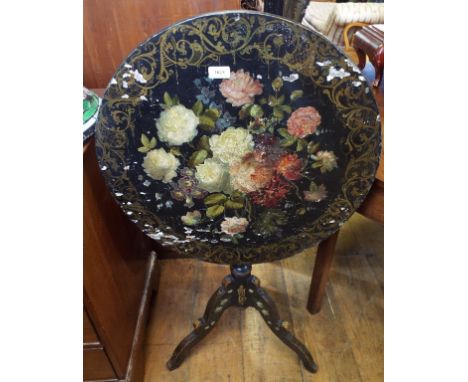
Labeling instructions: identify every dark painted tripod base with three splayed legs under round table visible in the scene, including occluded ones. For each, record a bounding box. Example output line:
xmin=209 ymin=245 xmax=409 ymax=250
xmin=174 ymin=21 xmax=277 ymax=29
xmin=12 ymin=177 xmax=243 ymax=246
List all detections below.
xmin=166 ymin=264 xmax=317 ymax=373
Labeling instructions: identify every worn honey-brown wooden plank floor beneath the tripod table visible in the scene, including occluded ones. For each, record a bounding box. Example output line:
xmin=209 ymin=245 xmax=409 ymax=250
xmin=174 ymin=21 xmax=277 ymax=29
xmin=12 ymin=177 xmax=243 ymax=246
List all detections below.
xmin=145 ymin=214 xmax=384 ymax=382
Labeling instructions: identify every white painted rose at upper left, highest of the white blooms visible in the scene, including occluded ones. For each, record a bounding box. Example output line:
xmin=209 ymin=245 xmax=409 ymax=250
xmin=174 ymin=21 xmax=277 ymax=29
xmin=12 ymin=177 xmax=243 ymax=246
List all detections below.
xmin=156 ymin=105 xmax=200 ymax=146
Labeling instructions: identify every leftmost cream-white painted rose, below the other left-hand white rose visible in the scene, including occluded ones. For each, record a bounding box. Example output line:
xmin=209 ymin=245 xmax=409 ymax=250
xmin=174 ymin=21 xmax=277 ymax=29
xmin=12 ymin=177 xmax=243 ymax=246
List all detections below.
xmin=143 ymin=149 xmax=180 ymax=183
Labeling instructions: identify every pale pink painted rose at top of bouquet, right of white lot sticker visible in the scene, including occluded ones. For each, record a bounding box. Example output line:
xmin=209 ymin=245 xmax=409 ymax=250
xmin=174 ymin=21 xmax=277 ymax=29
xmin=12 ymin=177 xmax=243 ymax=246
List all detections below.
xmin=219 ymin=69 xmax=263 ymax=106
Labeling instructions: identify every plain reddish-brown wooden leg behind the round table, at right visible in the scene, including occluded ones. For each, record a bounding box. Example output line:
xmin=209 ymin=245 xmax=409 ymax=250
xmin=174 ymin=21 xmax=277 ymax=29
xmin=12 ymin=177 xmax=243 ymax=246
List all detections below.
xmin=307 ymin=231 xmax=339 ymax=314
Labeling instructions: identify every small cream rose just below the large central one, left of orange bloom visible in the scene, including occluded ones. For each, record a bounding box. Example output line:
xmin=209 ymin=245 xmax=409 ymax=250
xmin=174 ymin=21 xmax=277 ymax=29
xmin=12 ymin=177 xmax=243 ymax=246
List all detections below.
xmin=195 ymin=158 xmax=229 ymax=192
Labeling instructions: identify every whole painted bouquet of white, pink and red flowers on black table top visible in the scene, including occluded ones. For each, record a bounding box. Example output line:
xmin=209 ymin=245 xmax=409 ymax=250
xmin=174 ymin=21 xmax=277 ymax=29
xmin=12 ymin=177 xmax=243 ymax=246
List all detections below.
xmin=138 ymin=69 xmax=339 ymax=244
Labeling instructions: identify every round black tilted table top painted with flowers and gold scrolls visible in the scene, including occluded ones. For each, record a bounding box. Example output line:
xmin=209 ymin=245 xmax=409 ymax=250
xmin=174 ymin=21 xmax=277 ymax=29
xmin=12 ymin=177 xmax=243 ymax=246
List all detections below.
xmin=96 ymin=11 xmax=380 ymax=264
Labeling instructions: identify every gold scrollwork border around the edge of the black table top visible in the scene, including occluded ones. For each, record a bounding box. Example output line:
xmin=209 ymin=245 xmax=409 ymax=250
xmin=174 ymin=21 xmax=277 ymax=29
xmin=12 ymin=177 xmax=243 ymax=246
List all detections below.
xmin=96 ymin=11 xmax=380 ymax=264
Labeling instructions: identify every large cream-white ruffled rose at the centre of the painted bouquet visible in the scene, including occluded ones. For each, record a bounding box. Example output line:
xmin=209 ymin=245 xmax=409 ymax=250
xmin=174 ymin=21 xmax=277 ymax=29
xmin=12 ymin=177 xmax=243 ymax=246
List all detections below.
xmin=209 ymin=127 xmax=254 ymax=165
